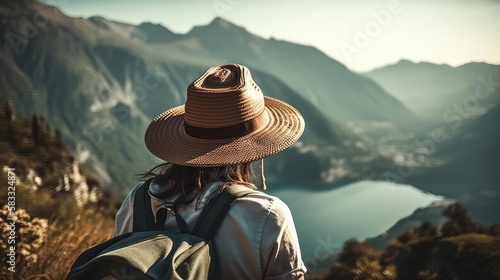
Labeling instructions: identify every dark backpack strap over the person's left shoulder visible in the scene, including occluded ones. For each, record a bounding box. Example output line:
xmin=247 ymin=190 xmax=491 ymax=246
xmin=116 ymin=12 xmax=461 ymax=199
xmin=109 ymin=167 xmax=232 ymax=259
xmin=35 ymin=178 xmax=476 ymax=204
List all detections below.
xmin=133 ymin=179 xmax=156 ymax=231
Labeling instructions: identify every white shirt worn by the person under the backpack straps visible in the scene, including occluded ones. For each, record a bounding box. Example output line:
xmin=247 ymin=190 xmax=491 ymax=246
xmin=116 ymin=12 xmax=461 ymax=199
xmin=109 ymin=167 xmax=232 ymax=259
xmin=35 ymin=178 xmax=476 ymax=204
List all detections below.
xmin=114 ymin=181 xmax=306 ymax=280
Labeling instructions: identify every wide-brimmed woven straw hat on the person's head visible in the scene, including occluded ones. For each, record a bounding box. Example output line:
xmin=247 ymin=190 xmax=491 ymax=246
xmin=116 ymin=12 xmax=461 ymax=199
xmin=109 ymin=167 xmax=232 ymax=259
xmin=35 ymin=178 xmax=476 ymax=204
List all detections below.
xmin=145 ymin=64 xmax=305 ymax=167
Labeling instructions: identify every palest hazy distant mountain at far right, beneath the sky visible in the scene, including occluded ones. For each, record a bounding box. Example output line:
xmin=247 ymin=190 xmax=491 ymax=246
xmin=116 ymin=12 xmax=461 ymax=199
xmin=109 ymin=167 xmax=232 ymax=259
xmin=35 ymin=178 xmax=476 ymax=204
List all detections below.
xmin=364 ymin=60 xmax=500 ymax=123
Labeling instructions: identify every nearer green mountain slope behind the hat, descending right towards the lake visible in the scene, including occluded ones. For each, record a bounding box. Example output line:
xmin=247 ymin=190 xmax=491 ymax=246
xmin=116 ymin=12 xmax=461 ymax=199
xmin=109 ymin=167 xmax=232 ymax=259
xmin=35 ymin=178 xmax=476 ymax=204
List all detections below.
xmin=0 ymin=0 xmax=391 ymax=194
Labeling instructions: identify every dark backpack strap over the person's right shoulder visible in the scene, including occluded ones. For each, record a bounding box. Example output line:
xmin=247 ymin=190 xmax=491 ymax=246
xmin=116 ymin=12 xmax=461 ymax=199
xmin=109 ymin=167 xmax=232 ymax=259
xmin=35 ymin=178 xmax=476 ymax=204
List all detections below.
xmin=192 ymin=184 xmax=255 ymax=240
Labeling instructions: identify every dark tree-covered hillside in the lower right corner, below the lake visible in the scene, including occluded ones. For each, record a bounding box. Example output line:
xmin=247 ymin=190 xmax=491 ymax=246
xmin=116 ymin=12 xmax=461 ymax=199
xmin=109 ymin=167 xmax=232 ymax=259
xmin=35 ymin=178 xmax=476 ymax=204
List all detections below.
xmin=308 ymin=203 xmax=500 ymax=280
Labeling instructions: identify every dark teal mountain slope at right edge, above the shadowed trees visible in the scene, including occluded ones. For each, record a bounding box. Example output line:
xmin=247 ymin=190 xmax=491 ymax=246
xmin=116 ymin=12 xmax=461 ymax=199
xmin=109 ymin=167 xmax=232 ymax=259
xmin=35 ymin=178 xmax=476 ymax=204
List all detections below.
xmin=408 ymin=99 xmax=500 ymax=225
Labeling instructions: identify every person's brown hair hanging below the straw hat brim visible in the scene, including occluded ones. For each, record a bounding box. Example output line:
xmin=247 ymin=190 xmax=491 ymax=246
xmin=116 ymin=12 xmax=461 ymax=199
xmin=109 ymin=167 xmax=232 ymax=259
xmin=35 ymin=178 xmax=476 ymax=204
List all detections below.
xmin=139 ymin=162 xmax=255 ymax=202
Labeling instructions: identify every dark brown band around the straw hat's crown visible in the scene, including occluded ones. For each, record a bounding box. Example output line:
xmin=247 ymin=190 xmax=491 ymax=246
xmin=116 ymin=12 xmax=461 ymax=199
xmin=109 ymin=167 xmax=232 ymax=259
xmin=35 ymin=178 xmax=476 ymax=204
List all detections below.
xmin=184 ymin=111 xmax=268 ymax=140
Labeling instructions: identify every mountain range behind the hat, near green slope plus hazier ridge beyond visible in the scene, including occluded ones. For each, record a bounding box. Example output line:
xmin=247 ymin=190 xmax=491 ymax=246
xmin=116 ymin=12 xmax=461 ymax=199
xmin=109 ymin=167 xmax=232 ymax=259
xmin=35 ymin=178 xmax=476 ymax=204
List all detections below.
xmin=0 ymin=0 xmax=402 ymax=193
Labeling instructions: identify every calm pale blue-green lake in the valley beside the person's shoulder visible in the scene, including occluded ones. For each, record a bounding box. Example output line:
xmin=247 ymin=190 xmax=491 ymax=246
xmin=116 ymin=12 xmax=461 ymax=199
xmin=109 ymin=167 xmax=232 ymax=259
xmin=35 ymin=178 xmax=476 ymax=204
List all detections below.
xmin=266 ymin=181 xmax=443 ymax=258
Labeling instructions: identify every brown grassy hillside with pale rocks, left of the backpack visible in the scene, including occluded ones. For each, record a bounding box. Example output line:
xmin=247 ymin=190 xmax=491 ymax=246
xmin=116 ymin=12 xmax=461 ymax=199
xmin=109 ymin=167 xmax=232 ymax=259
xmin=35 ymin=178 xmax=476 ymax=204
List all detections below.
xmin=0 ymin=102 xmax=119 ymax=280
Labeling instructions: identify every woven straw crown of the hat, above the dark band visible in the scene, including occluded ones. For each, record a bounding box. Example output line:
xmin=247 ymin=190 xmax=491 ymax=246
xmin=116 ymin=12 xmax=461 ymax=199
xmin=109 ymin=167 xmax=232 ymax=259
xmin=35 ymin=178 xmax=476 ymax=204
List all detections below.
xmin=184 ymin=64 xmax=265 ymax=128
